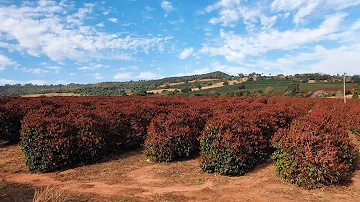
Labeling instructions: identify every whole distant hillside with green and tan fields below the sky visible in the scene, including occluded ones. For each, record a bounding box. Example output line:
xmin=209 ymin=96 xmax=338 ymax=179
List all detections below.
xmin=0 ymin=71 xmax=360 ymax=96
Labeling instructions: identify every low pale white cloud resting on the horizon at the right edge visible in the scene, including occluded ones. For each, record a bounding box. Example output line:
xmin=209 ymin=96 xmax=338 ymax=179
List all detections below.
xmin=247 ymin=44 xmax=360 ymax=75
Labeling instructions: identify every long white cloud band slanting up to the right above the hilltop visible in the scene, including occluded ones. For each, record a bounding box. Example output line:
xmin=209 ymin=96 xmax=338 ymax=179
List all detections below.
xmin=200 ymin=14 xmax=346 ymax=63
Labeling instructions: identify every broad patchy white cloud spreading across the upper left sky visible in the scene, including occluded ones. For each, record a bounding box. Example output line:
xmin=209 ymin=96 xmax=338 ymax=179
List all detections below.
xmin=0 ymin=2 xmax=172 ymax=63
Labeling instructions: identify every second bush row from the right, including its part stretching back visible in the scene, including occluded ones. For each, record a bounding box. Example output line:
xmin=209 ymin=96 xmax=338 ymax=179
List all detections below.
xmin=200 ymin=99 xmax=304 ymax=175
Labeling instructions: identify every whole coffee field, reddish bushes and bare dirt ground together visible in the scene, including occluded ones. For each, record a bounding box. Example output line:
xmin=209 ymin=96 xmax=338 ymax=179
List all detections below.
xmin=0 ymin=96 xmax=360 ymax=201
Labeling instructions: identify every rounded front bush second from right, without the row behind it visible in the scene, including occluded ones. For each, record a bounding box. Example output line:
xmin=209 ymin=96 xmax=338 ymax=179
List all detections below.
xmin=200 ymin=111 xmax=273 ymax=175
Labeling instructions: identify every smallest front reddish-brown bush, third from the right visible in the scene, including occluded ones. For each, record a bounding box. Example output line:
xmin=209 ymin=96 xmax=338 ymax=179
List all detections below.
xmin=145 ymin=109 xmax=204 ymax=162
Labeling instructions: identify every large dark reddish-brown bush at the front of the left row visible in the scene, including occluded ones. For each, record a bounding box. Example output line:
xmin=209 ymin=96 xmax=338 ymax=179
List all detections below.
xmin=21 ymin=106 xmax=106 ymax=172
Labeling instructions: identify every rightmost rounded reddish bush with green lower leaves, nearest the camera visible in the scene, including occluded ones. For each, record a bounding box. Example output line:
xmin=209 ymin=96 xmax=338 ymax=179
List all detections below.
xmin=272 ymin=110 xmax=355 ymax=188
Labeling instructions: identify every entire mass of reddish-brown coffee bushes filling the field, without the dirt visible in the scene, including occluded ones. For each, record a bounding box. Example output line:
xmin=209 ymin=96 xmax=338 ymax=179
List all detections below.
xmin=0 ymin=97 xmax=360 ymax=188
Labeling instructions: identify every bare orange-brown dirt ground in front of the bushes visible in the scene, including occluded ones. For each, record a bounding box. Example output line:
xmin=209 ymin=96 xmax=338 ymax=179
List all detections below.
xmin=0 ymin=143 xmax=360 ymax=202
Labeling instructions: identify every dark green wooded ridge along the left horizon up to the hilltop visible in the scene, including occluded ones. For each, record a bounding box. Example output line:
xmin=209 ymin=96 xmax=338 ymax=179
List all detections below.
xmin=0 ymin=71 xmax=231 ymax=96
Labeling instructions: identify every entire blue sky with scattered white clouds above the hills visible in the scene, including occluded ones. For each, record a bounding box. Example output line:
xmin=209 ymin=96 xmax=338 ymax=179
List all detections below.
xmin=0 ymin=0 xmax=360 ymax=85
